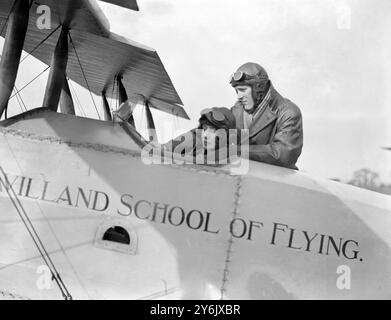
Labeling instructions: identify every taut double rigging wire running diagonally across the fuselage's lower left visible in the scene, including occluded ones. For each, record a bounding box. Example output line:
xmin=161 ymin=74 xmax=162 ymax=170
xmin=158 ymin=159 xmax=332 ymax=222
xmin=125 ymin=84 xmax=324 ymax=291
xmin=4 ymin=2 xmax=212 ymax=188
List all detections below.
xmin=0 ymin=167 xmax=72 ymax=300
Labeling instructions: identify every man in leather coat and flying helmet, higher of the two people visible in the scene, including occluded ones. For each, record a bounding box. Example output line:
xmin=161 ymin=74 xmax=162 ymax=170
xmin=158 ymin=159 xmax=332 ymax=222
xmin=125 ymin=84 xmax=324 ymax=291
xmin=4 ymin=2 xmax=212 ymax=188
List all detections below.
xmin=230 ymin=62 xmax=303 ymax=169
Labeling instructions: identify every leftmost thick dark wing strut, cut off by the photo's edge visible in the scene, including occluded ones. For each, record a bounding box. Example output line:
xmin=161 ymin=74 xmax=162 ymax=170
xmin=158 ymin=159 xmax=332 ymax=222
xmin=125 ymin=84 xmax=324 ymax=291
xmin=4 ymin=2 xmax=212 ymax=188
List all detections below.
xmin=0 ymin=0 xmax=30 ymax=117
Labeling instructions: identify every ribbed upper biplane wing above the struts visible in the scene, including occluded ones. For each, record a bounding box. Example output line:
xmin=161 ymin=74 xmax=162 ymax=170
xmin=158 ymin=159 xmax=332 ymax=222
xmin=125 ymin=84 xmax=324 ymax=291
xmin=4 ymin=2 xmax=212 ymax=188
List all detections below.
xmin=0 ymin=0 xmax=188 ymax=119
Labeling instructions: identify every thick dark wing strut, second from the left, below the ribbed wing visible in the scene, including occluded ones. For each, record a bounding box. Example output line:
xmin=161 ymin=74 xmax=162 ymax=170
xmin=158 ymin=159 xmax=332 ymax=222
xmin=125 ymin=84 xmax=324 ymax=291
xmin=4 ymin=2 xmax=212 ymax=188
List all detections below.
xmin=42 ymin=26 xmax=69 ymax=111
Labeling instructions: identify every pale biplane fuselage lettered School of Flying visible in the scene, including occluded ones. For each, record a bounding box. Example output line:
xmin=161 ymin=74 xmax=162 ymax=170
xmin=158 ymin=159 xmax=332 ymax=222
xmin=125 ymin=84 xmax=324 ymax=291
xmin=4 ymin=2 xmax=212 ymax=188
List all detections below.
xmin=0 ymin=0 xmax=391 ymax=299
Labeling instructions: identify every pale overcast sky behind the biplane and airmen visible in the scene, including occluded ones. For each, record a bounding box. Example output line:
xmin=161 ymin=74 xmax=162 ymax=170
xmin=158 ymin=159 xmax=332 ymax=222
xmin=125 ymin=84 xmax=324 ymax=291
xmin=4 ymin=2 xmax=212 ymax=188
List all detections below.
xmin=3 ymin=0 xmax=391 ymax=182
